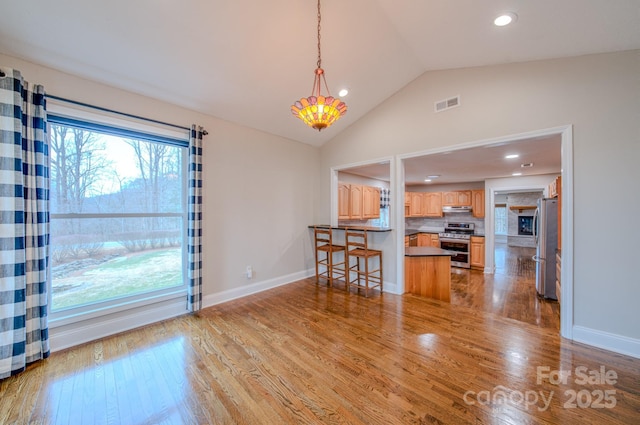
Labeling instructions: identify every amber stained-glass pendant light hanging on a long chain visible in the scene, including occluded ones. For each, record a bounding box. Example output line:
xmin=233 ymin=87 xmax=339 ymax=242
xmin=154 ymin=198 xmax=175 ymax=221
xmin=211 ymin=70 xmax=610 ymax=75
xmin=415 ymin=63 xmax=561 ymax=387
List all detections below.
xmin=291 ymin=0 xmax=347 ymax=131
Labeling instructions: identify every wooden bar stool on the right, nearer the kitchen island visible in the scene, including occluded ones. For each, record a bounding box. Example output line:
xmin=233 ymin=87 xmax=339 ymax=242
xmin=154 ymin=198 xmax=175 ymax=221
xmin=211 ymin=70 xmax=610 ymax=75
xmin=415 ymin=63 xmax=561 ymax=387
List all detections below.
xmin=345 ymin=229 xmax=382 ymax=297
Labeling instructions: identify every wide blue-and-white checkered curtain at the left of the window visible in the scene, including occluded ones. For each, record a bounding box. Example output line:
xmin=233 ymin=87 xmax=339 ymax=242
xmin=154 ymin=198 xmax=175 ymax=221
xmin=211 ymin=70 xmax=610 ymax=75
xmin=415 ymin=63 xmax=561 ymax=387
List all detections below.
xmin=0 ymin=68 xmax=49 ymax=379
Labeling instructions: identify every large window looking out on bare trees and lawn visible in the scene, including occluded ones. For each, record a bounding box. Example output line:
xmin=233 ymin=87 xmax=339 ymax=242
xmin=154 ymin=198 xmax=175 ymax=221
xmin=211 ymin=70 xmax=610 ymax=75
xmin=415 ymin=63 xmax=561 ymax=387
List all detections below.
xmin=49 ymin=114 xmax=187 ymax=313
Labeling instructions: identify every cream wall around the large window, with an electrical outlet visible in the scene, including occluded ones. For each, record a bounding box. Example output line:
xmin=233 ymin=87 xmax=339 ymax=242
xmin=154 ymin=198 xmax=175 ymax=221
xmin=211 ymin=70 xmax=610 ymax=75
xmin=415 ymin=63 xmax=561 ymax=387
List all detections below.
xmin=0 ymin=55 xmax=320 ymax=344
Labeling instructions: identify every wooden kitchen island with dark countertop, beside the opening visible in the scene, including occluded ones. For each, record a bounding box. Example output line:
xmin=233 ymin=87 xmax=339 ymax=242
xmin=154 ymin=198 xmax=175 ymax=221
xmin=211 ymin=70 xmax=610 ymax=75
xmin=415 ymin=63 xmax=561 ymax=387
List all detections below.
xmin=404 ymin=246 xmax=454 ymax=302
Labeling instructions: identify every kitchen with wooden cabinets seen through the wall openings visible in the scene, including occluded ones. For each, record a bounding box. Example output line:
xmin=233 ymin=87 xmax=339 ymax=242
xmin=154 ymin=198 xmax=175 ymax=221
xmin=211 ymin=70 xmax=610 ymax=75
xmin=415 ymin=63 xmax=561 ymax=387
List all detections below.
xmin=336 ymin=137 xmax=561 ymax=323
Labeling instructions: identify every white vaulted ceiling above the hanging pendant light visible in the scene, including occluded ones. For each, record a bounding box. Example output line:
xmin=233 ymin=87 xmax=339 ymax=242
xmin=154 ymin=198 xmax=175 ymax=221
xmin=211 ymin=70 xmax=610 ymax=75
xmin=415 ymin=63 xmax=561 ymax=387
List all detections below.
xmin=0 ymin=0 xmax=640 ymax=146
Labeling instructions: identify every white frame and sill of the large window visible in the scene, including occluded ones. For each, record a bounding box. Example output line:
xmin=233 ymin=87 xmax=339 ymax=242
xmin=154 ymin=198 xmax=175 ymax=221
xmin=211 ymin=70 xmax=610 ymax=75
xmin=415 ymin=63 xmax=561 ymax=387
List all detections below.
xmin=47 ymin=99 xmax=189 ymax=330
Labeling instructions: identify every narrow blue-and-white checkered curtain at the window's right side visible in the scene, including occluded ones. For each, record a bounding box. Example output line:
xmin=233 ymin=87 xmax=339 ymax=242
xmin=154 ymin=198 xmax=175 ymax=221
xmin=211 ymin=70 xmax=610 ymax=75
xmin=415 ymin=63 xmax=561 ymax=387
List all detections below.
xmin=187 ymin=125 xmax=206 ymax=311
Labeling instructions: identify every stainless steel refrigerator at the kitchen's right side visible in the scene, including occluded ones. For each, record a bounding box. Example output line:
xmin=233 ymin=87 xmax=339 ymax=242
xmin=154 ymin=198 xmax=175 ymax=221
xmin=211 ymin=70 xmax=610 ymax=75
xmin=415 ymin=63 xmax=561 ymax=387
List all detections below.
xmin=533 ymin=198 xmax=558 ymax=300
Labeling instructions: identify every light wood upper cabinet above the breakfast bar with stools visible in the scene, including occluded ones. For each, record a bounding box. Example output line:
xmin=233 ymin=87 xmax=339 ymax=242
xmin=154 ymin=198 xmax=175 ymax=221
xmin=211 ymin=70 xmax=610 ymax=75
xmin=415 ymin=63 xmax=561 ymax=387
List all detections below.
xmin=338 ymin=182 xmax=380 ymax=220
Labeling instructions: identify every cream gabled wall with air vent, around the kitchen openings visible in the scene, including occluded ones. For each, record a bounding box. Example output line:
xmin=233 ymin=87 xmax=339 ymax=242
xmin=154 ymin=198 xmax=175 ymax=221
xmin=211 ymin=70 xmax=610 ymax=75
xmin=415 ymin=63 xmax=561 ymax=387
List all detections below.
xmin=321 ymin=51 xmax=640 ymax=356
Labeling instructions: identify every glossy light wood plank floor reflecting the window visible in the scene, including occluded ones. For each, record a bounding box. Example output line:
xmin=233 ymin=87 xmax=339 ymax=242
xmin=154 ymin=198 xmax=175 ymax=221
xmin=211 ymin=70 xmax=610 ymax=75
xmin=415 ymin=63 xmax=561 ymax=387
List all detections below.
xmin=0 ymin=258 xmax=640 ymax=425
